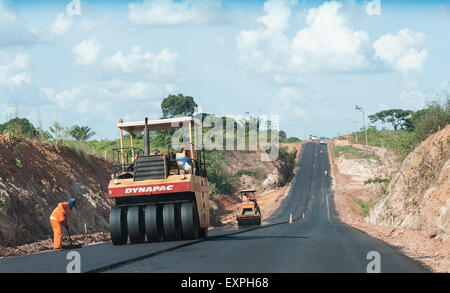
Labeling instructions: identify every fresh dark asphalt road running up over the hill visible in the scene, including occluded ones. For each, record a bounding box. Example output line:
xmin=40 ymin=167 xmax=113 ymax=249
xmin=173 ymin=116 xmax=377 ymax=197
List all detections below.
xmin=0 ymin=143 xmax=427 ymax=273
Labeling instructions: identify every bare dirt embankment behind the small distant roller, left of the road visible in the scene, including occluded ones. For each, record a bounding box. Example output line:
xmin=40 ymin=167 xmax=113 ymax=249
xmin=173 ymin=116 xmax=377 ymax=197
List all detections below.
xmin=211 ymin=142 xmax=304 ymax=226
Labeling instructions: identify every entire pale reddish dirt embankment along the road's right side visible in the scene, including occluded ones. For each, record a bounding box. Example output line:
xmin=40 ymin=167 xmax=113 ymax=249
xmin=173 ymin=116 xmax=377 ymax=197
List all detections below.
xmin=329 ymin=126 xmax=450 ymax=272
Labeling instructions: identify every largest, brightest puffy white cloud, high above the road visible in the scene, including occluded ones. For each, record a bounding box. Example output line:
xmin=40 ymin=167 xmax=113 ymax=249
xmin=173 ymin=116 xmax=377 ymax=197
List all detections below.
xmin=236 ymin=0 xmax=372 ymax=74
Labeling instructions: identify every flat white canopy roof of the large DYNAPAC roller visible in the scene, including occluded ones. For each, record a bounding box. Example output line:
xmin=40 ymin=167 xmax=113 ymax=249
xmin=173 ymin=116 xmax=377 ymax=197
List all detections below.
xmin=117 ymin=116 xmax=201 ymax=133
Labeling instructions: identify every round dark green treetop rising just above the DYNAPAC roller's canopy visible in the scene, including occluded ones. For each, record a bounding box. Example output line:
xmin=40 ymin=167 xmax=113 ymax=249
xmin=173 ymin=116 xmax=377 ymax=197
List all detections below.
xmin=161 ymin=94 xmax=197 ymax=118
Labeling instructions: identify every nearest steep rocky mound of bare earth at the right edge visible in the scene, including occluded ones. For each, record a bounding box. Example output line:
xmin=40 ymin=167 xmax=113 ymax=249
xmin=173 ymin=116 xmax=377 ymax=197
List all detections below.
xmin=369 ymin=125 xmax=450 ymax=239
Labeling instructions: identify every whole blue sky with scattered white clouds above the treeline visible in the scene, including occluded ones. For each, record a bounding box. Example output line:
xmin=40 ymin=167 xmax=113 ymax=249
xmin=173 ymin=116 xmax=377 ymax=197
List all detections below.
xmin=0 ymin=0 xmax=450 ymax=139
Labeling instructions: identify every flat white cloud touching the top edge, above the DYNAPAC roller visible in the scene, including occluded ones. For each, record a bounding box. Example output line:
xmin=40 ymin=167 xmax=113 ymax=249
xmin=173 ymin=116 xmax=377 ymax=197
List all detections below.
xmin=128 ymin=0 xmax=224 ymax=26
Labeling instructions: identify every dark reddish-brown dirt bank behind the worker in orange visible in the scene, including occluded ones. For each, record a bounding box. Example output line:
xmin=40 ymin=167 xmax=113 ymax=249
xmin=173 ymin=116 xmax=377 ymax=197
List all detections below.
xmin=0 ymin=135 xmax=112 ymax=247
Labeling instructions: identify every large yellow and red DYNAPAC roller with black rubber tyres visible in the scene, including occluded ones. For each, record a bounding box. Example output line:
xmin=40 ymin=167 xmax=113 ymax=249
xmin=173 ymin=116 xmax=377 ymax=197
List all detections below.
xmin=108 ymin=117 xmax=209 ymax=245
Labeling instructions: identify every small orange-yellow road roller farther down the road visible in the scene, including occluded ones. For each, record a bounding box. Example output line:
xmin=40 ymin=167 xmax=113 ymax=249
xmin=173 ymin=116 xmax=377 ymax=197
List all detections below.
xmin=236 ymin=189 xmax=261 ymax=227
